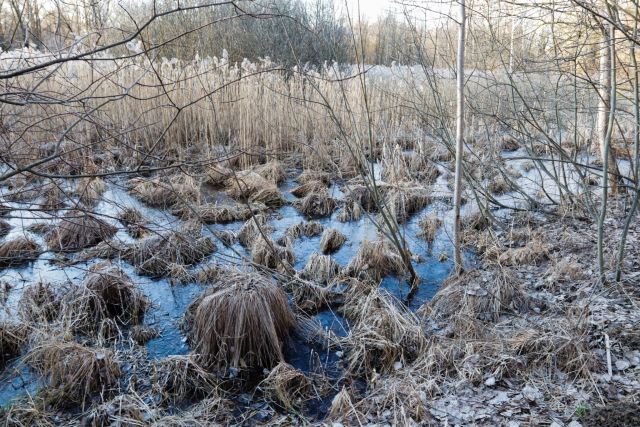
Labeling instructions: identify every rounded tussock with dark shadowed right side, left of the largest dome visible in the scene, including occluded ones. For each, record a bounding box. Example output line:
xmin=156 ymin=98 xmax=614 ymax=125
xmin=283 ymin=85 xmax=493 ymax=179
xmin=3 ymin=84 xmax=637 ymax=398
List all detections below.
xmin=63 ymin=263 xmax=150 ymax=333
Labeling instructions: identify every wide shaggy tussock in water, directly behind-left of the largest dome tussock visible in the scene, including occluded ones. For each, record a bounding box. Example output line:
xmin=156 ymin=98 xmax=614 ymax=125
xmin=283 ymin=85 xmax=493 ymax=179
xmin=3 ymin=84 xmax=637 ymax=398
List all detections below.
xmin=124 ymin=223 xmax=217 ymax=277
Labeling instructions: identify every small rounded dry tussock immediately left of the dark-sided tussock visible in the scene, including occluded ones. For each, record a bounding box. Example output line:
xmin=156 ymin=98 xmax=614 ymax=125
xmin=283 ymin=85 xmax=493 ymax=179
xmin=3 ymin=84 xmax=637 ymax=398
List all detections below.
xmin=18 ymin=281 xmax=60 ymax=323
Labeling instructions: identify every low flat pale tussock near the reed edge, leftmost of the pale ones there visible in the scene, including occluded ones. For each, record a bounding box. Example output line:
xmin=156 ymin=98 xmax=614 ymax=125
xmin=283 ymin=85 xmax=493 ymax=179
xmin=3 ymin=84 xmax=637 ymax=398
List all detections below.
xmin=129 ymin=174 xmax=200 ymax=209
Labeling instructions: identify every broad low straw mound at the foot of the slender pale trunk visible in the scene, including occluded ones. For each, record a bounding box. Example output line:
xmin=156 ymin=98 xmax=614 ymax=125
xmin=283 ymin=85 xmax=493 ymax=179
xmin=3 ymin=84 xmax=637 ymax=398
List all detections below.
xmin=421 ymin=270 xmax=528 ymax=322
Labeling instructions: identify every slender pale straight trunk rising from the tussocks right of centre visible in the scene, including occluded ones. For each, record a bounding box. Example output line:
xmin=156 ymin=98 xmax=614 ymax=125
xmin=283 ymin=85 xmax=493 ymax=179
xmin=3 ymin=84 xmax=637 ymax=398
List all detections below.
xmin=453 ymin=0 xmax=466 ymax=273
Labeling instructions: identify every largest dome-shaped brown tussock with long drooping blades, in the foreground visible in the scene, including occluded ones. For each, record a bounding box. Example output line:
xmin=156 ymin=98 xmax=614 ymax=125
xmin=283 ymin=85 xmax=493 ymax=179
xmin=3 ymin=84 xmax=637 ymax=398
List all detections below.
xmin=188 ymin=271 xmax=295 ymax=368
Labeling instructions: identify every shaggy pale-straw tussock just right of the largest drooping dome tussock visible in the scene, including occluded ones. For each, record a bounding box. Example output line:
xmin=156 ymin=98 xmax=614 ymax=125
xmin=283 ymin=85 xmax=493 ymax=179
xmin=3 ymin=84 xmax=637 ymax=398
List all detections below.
xmin=345 ymin=289 xmax=426 ymax=376
